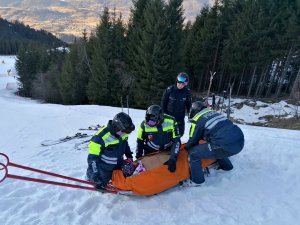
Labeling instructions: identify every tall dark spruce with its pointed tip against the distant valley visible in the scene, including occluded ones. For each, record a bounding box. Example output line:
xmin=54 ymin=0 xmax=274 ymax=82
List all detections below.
xmin=88 ymin=8 xmax=130 ymax=106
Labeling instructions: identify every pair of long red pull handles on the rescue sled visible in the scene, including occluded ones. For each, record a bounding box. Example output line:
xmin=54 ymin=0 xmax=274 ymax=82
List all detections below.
xmin=0 ymin=153 xmax=97 ymax=191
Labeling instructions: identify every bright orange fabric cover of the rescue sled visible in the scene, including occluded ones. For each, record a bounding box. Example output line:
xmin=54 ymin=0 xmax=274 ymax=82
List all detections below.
xmin=112 ymin=145 xmax=215 ymax=196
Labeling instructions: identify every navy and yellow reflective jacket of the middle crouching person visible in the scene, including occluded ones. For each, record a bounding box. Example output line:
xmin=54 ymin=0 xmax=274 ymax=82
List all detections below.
xmin=136 ymin=114 xmax=180 ymax=160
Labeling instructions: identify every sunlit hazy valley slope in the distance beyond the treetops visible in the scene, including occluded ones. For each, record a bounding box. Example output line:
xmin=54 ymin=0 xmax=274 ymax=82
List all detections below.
xmin=0 ymin=0 xmax=213 ymax=41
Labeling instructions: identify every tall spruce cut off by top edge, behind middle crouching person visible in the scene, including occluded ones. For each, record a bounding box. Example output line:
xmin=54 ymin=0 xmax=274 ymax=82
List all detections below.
xmin=134 ymin=0 xmax=171 ymax=107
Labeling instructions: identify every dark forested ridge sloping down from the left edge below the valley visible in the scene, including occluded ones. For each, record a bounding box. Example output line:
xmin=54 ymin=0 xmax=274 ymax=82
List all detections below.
xmin=0 ymin=17 xmax=65 ymax=55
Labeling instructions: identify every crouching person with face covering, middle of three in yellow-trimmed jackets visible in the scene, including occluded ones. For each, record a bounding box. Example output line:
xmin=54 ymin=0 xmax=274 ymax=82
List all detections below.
xmin=136 ymin=105 xmax=180 ymax=172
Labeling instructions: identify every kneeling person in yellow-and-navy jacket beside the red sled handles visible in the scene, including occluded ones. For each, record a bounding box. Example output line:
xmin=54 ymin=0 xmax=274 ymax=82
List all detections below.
xmin=87 ymin=112 xmax=135 ymax=189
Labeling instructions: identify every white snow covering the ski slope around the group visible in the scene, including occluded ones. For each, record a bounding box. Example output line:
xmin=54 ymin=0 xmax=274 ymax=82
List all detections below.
xmin=0 ymin=56 xmax=300 ymax=225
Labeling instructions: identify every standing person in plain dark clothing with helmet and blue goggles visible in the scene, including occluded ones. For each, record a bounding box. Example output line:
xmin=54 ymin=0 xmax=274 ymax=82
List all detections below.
xmin=161 ymin=72 xmax=192 ymax=136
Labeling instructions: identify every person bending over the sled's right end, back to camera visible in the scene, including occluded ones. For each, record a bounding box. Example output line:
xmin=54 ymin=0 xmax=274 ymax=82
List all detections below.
xmin=185 ymin=101 xmax=244 ymax=186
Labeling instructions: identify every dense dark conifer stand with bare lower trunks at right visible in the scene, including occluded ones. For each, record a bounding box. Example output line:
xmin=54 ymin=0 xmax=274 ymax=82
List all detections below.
xmin=184 ymin=0 xmax=300 ymax=97
